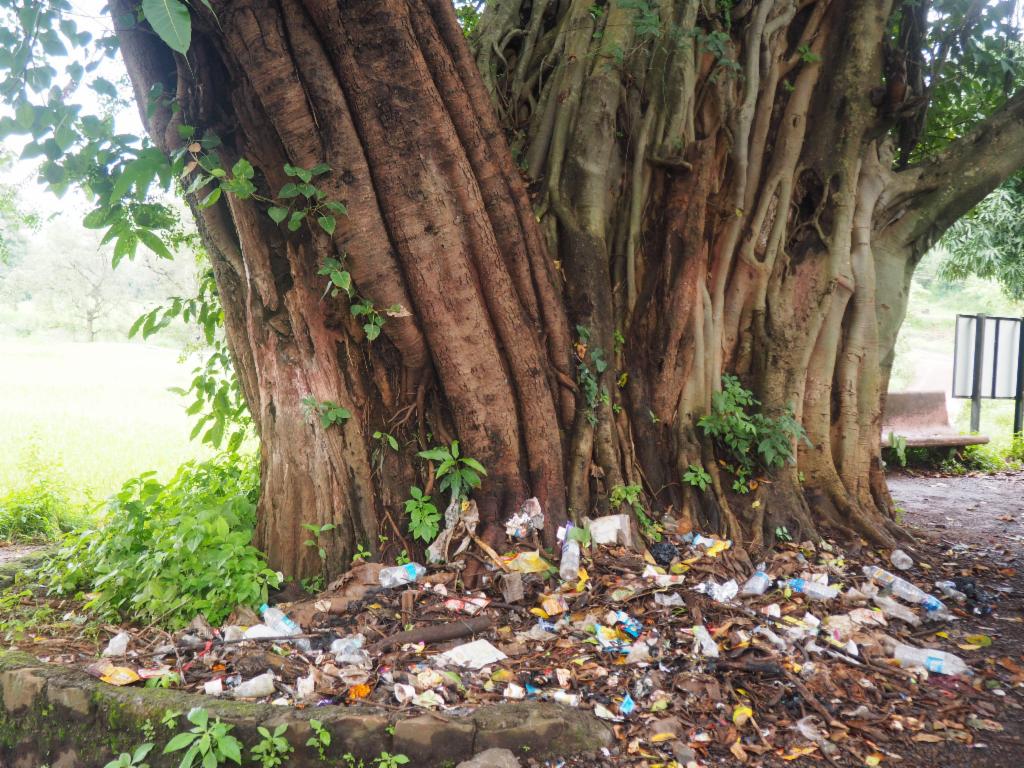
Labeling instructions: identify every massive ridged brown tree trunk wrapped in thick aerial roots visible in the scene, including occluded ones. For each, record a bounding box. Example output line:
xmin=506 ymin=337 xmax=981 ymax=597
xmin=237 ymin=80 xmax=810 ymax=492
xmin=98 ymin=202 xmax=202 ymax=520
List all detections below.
xmin=114 ymin=0 xmax=1020 ymax=575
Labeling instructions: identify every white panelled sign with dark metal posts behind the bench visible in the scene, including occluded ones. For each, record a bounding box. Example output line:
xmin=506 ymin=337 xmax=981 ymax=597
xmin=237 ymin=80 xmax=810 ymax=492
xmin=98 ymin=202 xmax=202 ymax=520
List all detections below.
xmin=952 ymin=314 xmax=1024 ymax=432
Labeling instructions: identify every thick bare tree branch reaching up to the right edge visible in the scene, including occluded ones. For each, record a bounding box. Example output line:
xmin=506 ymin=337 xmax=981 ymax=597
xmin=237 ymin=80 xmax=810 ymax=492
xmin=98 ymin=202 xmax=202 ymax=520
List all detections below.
xmin=874 ymin=90 xmax=1024 ymax=258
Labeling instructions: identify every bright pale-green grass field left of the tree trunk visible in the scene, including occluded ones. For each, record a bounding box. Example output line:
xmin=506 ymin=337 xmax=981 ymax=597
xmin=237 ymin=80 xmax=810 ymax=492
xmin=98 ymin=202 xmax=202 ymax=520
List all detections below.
xmin=0 ymin=340 xmax=211 ymax=502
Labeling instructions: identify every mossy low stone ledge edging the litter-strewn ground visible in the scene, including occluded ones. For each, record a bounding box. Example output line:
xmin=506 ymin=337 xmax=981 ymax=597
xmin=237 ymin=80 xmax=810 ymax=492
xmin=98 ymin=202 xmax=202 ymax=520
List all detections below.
xmin=0 ymin=651 xmax=612 ymax=768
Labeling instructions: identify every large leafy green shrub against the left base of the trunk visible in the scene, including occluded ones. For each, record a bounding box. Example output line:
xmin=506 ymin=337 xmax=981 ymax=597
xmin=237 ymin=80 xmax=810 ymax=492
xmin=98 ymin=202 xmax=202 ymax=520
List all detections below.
xmin=40 ymin=454 xmax=280 ymax=628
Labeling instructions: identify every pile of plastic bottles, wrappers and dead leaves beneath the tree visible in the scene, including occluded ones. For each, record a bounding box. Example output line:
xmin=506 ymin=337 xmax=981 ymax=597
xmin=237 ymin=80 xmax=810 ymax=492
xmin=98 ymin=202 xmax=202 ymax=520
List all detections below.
xmin=32 ymin=500 xmax=1024 ymax=766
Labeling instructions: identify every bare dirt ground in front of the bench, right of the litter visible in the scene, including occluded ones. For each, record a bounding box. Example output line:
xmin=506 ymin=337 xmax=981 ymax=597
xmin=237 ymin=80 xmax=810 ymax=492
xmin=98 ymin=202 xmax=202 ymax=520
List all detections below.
xmin=889 ymin=472 xmax=1024 ymax=768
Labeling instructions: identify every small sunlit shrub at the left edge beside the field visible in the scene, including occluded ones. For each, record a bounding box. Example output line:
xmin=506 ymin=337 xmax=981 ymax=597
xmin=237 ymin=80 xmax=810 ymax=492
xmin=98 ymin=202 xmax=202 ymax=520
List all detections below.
xmin=0 ymin=447 xmax=87 ymax=542
